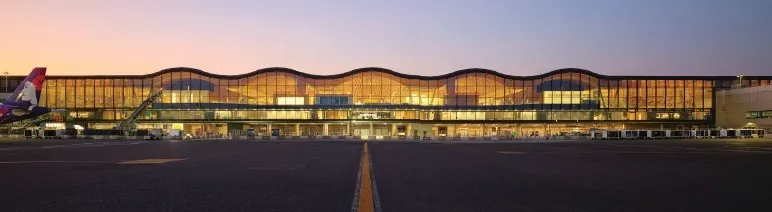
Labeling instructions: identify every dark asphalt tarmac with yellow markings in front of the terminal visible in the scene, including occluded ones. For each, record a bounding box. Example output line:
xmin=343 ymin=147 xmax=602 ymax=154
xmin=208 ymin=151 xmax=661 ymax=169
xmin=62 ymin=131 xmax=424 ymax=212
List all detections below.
xmin=0 ymin=139 xmax=772 ymax=211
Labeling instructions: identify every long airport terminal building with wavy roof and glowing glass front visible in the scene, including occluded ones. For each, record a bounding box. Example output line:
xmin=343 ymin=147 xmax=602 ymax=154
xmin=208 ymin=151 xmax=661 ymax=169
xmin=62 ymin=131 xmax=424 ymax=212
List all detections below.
xmin=0 ymin=68 xmax=772 ymax=136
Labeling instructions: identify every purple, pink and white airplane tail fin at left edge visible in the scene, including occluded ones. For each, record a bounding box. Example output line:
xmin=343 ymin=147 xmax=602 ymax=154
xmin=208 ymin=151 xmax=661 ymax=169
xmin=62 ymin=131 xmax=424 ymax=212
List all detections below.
xmin=3 ymin=67 xmax=46 ymax=105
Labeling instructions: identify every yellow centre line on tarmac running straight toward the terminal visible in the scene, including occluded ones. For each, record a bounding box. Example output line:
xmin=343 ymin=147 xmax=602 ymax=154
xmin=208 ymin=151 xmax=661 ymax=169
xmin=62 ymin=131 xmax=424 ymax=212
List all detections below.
xmin=351 ymin=142 xmax=381 ymax=212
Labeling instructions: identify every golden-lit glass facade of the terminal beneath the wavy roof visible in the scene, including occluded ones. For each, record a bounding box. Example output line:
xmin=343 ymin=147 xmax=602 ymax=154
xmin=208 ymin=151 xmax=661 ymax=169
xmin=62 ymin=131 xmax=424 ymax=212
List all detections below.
xmin=28 ymin=68 xmax=770 ymax=123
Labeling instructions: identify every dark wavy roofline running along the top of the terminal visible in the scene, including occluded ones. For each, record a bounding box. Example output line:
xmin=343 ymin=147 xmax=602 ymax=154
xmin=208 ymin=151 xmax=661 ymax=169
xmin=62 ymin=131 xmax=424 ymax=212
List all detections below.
xmin=50 ymin=67 xmax=772 ymax=80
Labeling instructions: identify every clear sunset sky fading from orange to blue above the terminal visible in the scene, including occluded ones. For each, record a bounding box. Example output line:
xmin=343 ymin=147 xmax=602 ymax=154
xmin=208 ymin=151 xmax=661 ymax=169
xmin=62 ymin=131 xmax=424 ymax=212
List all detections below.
xmin=0 ymin=0 xmax=772 ymax=76
